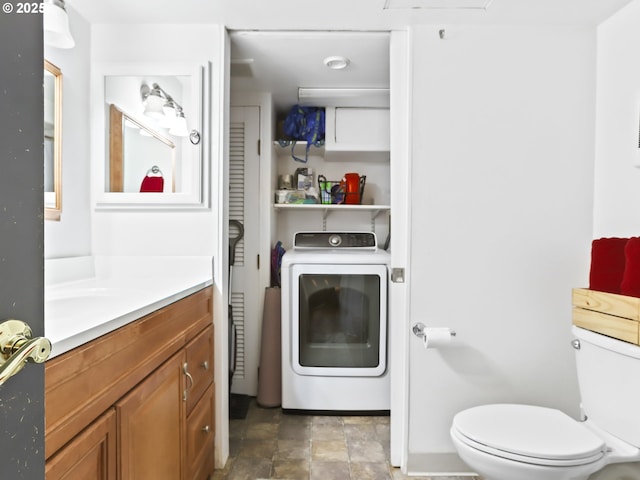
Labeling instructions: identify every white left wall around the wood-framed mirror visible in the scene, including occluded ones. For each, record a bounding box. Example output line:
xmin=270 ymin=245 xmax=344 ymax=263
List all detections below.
xmin=44 ymin=5 xmax=91 ymax=258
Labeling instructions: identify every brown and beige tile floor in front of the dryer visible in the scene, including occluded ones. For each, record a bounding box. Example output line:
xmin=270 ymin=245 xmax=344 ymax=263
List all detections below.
xmin=213 ymin=399 xmax=472 ymax=480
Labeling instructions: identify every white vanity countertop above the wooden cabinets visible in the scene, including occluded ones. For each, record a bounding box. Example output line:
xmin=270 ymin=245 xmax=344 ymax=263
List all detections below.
xmin=44 ymin=257 xmax=213 ymax=358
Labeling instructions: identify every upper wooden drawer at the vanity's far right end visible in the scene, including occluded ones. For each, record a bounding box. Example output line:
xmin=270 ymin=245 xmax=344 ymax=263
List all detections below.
xmin=186 ymin=325 xmax=213 ymax=414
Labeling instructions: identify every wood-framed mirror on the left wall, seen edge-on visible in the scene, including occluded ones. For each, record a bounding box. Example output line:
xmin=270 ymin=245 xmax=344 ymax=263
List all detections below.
xmin=44 ymin=60 xmax=62 ymax=221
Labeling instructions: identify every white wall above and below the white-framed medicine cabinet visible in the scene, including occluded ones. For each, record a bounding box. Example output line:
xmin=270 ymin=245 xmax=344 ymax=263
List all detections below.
xmin=91 ymin=25 xmax=222 ymax=255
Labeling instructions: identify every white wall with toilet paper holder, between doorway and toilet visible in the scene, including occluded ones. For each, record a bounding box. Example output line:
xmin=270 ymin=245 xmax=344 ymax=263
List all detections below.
xmin=405 ymin=26 xmax=596 ymax=472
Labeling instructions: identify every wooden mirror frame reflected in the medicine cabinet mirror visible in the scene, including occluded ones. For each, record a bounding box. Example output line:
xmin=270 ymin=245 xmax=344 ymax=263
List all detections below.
xmin=109 ymin=103 xmax=176 ymax=192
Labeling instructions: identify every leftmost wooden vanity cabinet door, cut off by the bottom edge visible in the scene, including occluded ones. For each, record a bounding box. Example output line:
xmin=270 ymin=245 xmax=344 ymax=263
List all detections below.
xmin=45 ymin=409 xmax=117 ymax=480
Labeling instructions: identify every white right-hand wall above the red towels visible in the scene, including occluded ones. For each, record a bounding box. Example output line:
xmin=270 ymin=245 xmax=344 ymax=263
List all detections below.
xmin=593 ymin=0 xmax=640 ymax=238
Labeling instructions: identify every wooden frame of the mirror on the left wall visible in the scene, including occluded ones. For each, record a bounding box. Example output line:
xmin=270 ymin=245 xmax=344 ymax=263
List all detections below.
xmin=43 ymin=60 xmax=62 ymax=221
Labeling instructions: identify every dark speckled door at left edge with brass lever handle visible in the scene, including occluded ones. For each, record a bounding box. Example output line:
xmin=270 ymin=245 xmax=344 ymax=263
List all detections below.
xmin=0 ymin=7 xmax=44 ymax=480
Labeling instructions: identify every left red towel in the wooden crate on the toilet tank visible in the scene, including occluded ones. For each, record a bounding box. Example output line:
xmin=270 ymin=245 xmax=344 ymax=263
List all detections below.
xmin=589 ymin=237 xmax=640 ymax=293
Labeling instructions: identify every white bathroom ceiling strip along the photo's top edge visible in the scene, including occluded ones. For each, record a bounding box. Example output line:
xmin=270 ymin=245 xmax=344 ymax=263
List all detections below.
xmin=67 ymin=0 xmax=638 ymax=30
